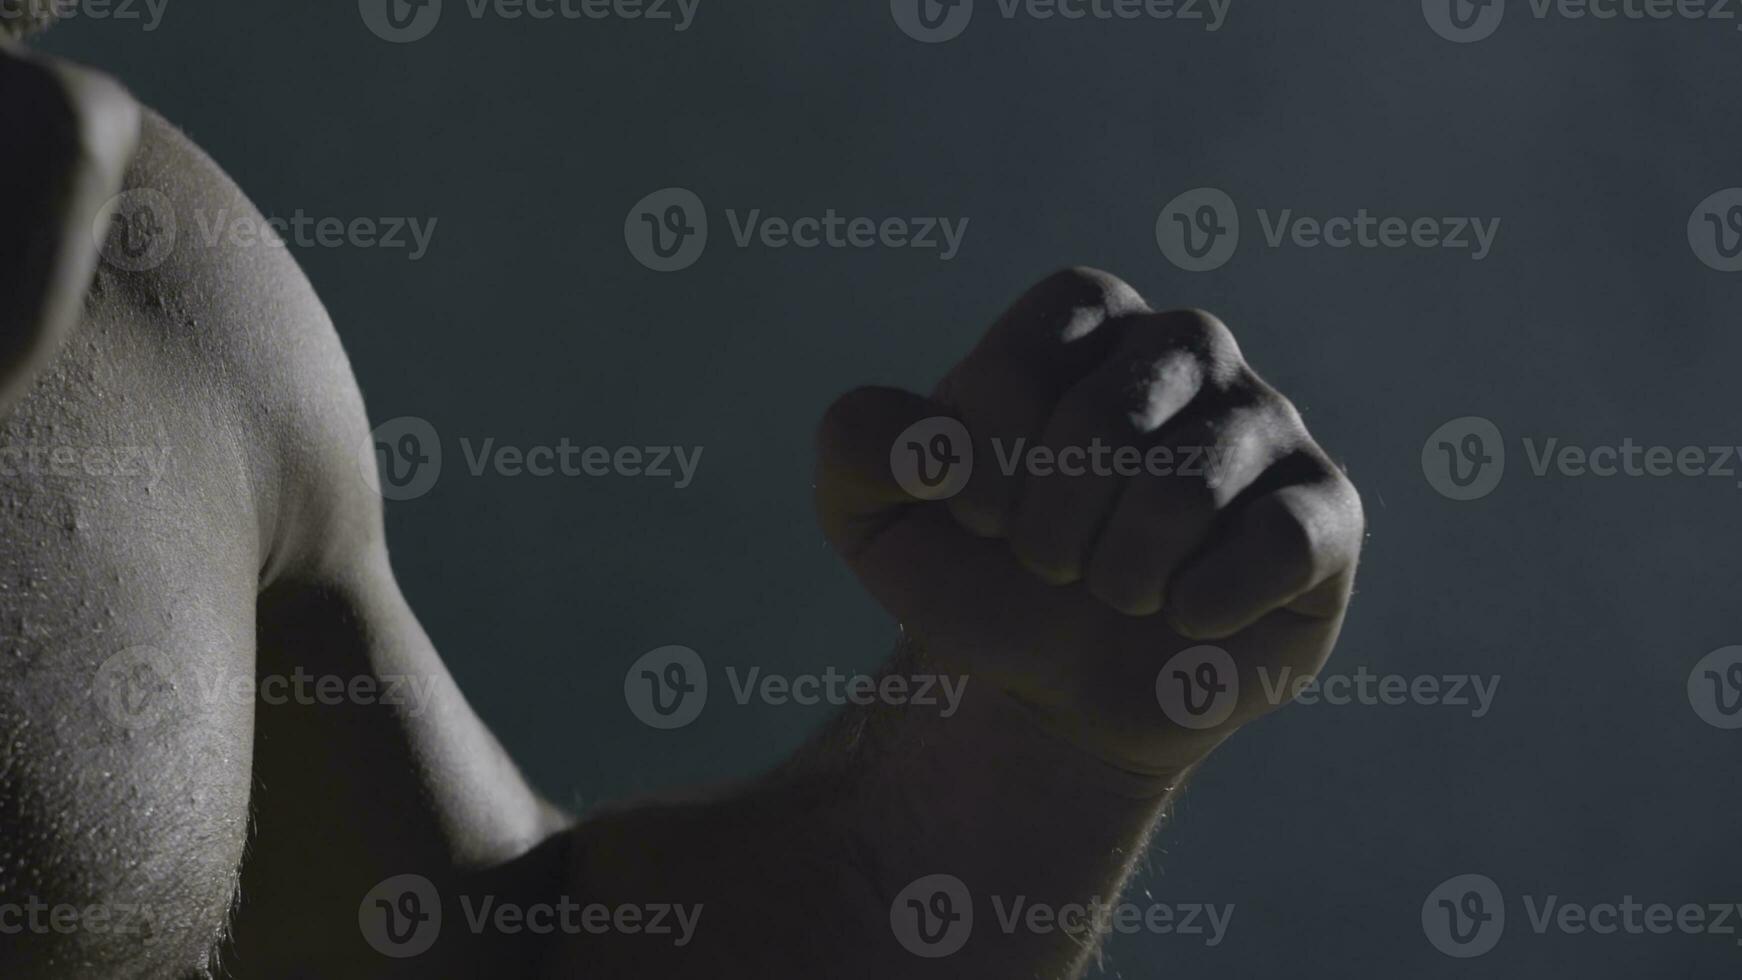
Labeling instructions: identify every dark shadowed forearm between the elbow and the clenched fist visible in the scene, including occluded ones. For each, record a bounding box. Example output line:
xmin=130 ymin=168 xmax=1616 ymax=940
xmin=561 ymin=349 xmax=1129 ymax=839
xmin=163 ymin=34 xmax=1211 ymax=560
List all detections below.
xmin=559 ymin=640 xmax=1178 ymax=977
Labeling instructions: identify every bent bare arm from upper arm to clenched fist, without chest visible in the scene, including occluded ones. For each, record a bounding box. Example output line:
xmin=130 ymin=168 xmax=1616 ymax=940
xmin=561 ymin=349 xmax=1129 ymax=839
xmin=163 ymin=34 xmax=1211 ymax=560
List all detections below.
xmin=240 ymin=272 xmax=1362 ymax=978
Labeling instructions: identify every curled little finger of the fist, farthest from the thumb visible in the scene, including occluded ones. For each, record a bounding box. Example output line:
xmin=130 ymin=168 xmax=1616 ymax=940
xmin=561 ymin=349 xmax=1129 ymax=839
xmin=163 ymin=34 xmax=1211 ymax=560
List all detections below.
xmin=1165 ymin=449 xmax=1362 ymax=639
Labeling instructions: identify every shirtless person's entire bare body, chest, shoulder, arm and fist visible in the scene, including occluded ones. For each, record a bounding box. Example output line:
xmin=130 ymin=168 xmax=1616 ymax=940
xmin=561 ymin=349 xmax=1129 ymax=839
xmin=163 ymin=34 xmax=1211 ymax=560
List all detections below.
xmin=0 ymin=38 xmax=1362 ymax=978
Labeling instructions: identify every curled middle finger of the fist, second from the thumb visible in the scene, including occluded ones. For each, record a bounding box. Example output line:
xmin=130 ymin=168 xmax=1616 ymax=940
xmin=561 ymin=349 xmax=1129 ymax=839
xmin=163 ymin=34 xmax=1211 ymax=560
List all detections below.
xmin=1010 ymin=313 xmax=1205 ymax=585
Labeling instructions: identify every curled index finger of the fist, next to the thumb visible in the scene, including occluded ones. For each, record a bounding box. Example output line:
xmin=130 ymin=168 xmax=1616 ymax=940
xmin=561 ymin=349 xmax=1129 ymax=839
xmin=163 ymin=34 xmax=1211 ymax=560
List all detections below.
xmin=935 ymin=268 xmax=1148 ymax=538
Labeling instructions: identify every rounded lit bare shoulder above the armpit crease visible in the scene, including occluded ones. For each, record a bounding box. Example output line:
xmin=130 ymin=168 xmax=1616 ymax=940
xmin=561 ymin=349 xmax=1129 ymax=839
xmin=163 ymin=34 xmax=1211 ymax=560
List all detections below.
xmin=92 ymin=111 xmax=381 ymax=585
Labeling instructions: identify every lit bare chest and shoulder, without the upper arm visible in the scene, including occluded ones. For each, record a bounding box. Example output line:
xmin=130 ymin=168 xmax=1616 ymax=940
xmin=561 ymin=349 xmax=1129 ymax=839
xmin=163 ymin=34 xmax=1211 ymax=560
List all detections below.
xmin=0 ymin=97 xmax=383 ymax=977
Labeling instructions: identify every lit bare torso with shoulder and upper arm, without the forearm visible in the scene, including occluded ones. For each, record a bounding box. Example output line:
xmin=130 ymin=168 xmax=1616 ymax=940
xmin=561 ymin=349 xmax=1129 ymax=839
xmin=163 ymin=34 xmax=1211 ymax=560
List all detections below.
xmin=0 ymin=109 xmax=563 ymax=978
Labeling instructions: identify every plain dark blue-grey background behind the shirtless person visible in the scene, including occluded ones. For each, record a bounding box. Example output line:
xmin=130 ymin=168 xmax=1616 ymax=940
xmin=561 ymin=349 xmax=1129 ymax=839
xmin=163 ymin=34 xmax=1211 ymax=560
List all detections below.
xmin=45 ymin=0 xmax=1742 ymax=978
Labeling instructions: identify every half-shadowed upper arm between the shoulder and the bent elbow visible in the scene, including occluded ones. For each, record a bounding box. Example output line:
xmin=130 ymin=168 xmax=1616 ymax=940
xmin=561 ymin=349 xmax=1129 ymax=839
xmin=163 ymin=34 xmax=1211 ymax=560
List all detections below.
xmin=224 ymin=213 xmax=566 ymax=971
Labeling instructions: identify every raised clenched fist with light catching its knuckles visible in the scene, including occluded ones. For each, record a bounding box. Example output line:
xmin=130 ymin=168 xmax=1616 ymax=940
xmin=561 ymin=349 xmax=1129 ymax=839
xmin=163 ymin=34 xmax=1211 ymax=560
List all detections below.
xmin=817 ymin=270 xmax=1364 ymax=780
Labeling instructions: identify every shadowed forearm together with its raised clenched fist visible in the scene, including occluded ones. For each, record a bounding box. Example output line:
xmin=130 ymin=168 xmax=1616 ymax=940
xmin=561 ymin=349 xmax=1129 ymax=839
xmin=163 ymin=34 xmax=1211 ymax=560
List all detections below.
xmin=543 ymin=270 xmax=1362 ymax=978
